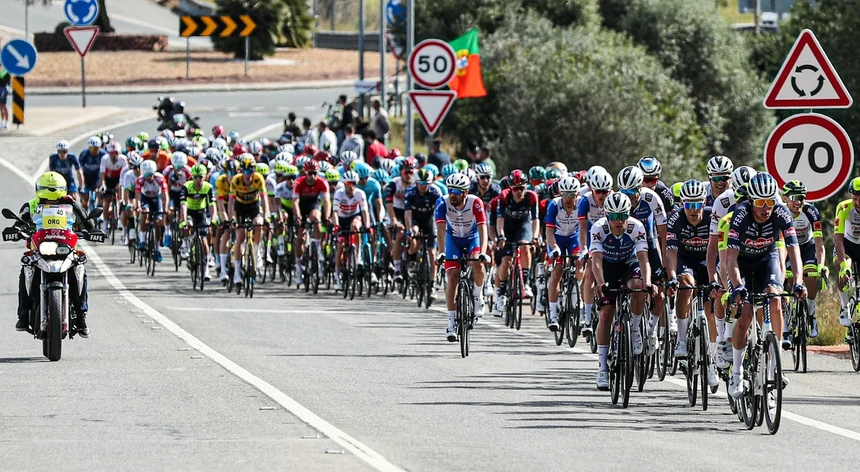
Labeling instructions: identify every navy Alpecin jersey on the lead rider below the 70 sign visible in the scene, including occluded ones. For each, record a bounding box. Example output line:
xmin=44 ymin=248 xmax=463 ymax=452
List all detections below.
xmin=728 ymin=202 xmax=797 ymax=259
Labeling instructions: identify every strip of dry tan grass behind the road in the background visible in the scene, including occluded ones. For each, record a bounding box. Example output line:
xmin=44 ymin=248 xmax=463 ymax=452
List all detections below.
xmin=27 ymin=49 xmax=396 ymax=87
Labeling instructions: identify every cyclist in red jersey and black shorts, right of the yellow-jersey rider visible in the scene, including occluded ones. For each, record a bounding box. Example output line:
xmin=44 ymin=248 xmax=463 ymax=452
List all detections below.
xmin=293 ymin=160 xmax=331 ymax=285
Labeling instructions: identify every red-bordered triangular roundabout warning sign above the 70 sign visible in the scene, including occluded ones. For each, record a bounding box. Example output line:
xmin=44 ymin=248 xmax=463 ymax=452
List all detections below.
xmin=764 ymin=29 xmax=853 ymax=108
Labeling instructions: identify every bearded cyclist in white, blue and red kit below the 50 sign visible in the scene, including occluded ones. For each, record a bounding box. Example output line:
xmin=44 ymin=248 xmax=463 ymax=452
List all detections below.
xmin=435 ymin=173 xmax=489 ymax=342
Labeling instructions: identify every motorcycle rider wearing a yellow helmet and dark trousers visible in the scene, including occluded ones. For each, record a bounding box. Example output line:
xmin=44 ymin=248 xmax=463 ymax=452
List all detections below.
xmin=15 ymin=172 xmax=95 ymax=338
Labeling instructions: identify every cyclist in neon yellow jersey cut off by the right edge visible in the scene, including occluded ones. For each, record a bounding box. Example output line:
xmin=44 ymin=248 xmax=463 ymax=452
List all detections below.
xmin=833 ymin=177 xmax=860 ymax=327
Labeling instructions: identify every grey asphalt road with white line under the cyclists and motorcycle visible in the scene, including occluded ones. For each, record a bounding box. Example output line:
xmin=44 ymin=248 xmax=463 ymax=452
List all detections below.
xmin=0 ymin=108 xmax=860 ymax=471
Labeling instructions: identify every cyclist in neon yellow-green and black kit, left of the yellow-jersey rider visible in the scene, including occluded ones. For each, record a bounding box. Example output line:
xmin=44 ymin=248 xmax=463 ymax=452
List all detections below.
xmin=179 ymin=164 xmax=217 ymax=281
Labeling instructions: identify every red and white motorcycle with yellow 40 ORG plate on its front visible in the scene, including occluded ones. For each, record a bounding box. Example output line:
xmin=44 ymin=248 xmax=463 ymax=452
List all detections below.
xmin=2 ymin=204 xmax=105 ymax=362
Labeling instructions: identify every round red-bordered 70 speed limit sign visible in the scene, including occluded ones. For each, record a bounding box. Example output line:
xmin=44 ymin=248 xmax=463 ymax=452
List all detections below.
xmin=764 ymin=113 xmax=854 ymax=201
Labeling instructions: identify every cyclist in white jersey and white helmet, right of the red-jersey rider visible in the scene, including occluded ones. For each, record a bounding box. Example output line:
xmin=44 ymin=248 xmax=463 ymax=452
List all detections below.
xmin=332 ymin=171 xmax=370 ymax=290
